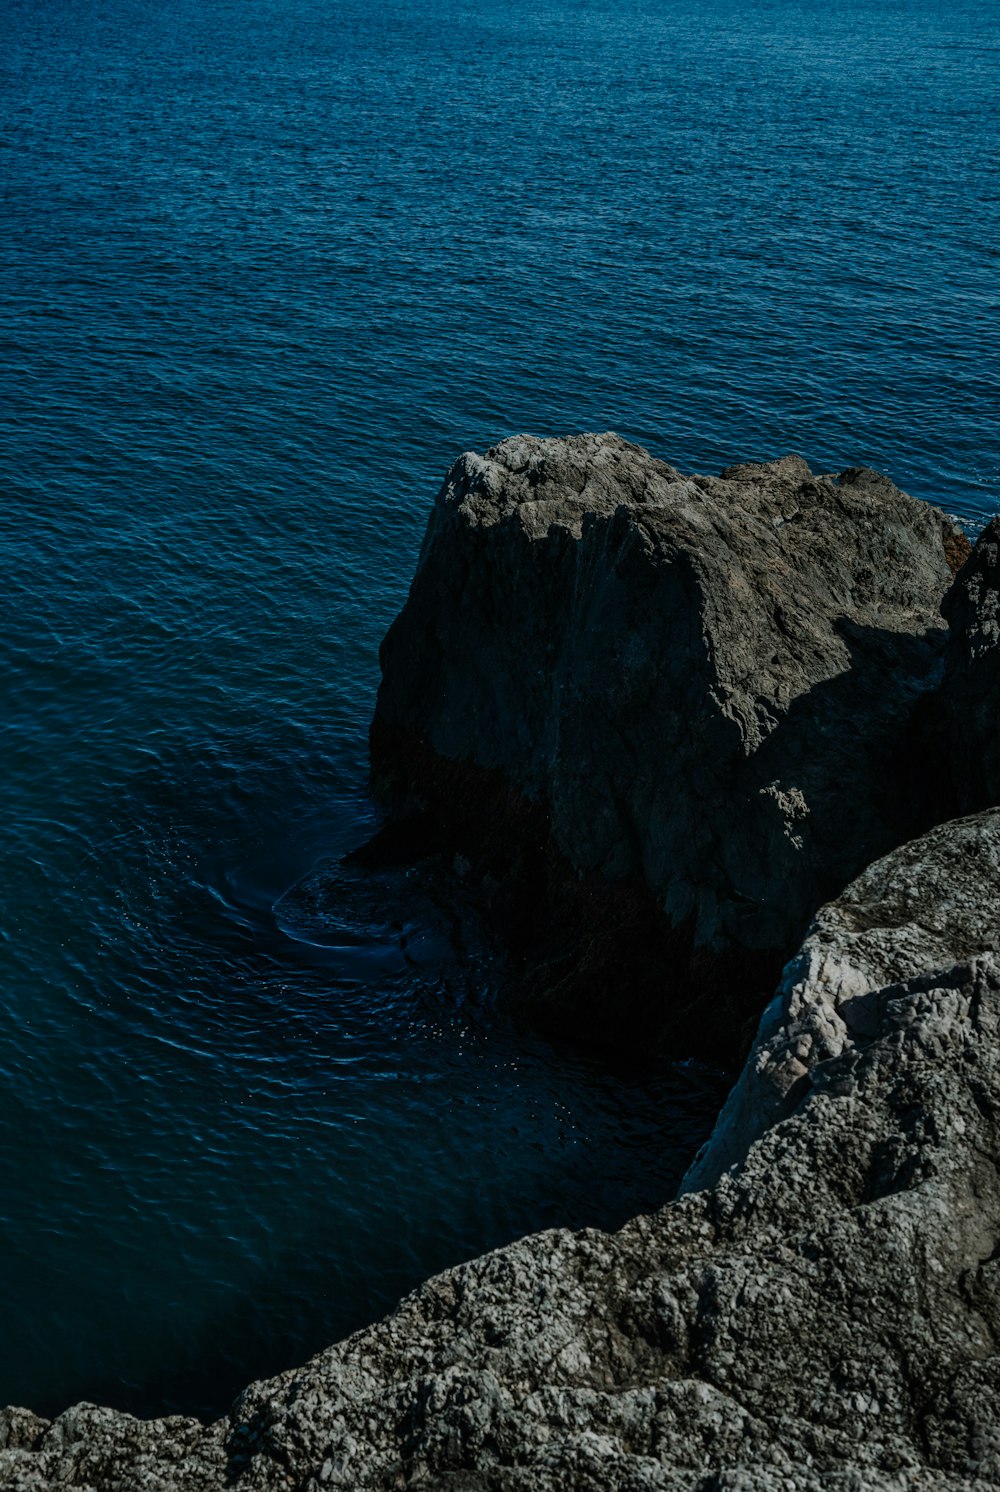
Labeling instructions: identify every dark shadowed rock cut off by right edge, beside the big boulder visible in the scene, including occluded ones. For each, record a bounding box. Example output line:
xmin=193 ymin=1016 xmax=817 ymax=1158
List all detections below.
xmin=936 ymin=518 xmax=1000 ymax=810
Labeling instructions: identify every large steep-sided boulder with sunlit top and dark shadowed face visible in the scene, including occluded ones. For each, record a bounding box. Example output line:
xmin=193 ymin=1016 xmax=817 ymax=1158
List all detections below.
xmin=372 ymin=436 xmax=967 ymax=1050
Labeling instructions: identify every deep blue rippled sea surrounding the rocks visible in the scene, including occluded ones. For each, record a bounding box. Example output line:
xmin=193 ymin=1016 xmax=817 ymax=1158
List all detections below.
xmin=0 ymin=0 xmax=1000 ymax=1414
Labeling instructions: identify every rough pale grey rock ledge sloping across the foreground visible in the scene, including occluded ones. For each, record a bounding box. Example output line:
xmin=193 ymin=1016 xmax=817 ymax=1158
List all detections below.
xmin=0 ymin=813 xmax=1000 ymax=1492
